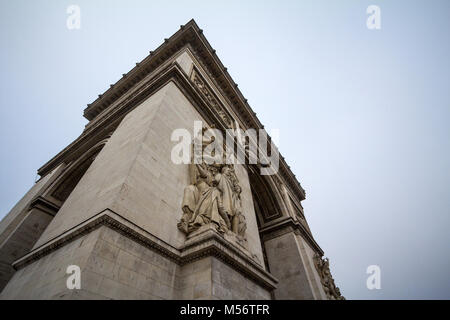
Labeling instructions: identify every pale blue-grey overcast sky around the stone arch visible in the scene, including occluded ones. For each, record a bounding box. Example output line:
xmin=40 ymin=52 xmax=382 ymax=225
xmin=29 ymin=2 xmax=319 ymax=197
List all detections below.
xmin=0 ymin=0 xmax=450 ymax=299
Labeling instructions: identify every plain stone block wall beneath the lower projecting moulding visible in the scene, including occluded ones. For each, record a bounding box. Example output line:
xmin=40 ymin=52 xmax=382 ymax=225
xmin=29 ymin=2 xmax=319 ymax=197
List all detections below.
xmin=0 ymin=226 xmax=270 ymax=299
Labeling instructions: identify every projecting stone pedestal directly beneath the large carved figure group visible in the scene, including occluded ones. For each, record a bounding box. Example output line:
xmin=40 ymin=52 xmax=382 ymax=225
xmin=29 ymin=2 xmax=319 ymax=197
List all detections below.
xmin=176 ymin=225 xmax=277 ymax=299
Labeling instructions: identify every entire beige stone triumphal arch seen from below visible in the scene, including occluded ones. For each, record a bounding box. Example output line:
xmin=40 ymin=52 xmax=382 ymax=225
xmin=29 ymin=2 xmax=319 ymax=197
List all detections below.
xmin=0 ymin=20 xmax=341 ymax=299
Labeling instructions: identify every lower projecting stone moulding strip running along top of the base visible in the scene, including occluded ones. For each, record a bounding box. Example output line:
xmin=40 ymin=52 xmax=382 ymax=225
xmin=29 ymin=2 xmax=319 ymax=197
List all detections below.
xmin=12 ymin=209 xmax=278 ymax=290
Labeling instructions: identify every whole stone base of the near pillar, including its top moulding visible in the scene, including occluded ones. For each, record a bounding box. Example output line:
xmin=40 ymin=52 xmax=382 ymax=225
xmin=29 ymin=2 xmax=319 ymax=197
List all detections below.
xmin=0 ymin=210 xmax=276 ymax=299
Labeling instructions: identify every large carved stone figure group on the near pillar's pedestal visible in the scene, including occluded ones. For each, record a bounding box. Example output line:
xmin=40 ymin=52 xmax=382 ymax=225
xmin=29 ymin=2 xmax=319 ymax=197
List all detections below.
xmin=178 ymin=128 xmax=247 ymax=240
